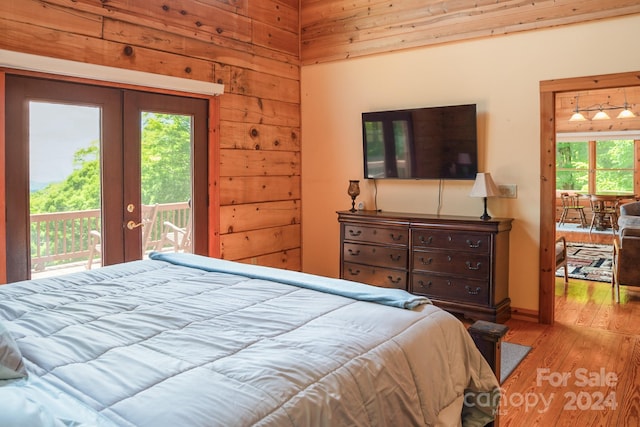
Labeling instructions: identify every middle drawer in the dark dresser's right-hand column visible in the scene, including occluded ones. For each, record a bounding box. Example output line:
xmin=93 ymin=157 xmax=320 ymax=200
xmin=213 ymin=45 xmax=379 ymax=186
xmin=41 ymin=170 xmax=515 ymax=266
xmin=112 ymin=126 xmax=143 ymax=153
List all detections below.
xmin=413 ymin=251 xmax=491 ymax=280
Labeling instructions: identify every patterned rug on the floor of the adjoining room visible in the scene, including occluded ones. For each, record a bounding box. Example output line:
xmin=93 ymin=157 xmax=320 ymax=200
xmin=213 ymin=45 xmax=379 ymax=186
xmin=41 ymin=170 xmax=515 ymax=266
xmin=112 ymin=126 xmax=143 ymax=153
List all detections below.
xmin=556 ymin=243 xmax=613 ymax=282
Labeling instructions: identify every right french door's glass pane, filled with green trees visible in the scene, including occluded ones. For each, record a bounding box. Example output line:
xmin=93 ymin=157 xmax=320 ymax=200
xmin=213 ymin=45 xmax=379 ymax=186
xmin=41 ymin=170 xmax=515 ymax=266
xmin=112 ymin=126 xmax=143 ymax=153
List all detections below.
xmin=140 ymin=111 xmax=193 ymax=257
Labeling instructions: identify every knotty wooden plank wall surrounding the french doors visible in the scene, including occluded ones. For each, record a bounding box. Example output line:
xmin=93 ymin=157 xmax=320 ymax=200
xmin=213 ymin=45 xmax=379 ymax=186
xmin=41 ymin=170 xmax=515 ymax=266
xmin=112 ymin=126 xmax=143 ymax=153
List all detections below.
xmin=0 ymin=0 xmax=301 ymax=270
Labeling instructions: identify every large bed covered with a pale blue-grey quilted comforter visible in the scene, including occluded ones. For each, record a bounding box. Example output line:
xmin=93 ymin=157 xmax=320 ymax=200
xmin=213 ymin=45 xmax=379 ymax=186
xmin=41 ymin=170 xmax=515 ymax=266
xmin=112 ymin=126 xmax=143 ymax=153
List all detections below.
xmin=0 ymin=253 xmax=499 ymax=427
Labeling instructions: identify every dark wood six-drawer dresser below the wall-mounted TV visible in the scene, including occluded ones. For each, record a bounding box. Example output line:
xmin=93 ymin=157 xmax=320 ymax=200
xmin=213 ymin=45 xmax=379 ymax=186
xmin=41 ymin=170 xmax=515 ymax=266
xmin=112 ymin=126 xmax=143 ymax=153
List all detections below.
xmin=338 ymin=211 xmax=513 ymax=323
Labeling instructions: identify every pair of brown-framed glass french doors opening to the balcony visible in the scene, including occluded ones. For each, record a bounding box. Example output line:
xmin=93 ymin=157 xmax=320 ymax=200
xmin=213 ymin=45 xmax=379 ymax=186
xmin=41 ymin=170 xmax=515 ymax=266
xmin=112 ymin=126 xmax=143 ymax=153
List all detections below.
xmin=5 ymin=75 xmax=208 ymax=282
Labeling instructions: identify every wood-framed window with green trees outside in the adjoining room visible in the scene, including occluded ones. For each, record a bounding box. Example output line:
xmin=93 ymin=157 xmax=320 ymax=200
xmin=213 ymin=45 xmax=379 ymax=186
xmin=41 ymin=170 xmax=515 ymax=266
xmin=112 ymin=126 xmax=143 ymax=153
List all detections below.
xmin=556 ymin=139 xmax=638 ymax=194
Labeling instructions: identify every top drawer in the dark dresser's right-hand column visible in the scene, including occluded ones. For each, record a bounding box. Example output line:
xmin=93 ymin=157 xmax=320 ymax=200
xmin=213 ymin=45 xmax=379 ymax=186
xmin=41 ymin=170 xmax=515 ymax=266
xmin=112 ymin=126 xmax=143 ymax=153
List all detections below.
xmin=412 ymin=229 xmax=491 ymax=254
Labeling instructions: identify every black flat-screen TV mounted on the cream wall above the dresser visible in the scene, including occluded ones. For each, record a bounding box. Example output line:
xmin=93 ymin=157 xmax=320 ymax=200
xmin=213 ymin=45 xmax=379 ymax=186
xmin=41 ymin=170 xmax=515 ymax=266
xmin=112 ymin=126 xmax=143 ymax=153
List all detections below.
xmin=362 ymin=104 xmax=478 ymax=180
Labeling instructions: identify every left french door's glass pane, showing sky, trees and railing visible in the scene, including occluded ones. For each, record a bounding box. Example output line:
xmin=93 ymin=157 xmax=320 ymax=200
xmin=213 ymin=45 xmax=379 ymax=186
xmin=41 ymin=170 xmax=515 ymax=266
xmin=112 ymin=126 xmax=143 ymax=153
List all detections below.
xmin=29 ymin=101 xmax=102 ymax=277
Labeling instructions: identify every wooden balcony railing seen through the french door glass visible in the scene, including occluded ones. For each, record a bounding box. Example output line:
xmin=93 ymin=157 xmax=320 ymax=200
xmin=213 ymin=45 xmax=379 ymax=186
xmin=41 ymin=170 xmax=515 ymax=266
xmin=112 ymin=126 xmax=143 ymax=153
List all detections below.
xmin=31 ymin=202 xmax=190 ymax=273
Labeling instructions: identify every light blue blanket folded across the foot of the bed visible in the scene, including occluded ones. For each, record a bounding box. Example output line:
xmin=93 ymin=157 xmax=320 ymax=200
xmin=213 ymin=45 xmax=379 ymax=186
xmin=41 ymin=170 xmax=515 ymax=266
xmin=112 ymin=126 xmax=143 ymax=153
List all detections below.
xmin=149 ymin=252 xmax=431 ymax=309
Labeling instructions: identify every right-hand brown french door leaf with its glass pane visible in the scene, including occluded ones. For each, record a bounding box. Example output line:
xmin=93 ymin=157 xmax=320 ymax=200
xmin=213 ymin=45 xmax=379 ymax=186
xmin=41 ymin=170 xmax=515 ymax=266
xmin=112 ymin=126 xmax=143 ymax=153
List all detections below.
xmin=123 ymin=91 xmax=208 ymax=261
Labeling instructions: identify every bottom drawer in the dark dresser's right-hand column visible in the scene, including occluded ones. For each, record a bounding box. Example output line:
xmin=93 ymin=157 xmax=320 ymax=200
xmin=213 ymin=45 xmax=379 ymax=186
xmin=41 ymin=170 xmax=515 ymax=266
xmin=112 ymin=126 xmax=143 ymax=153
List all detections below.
xmin=411 ymin=273 xmax=489 ymax=304
